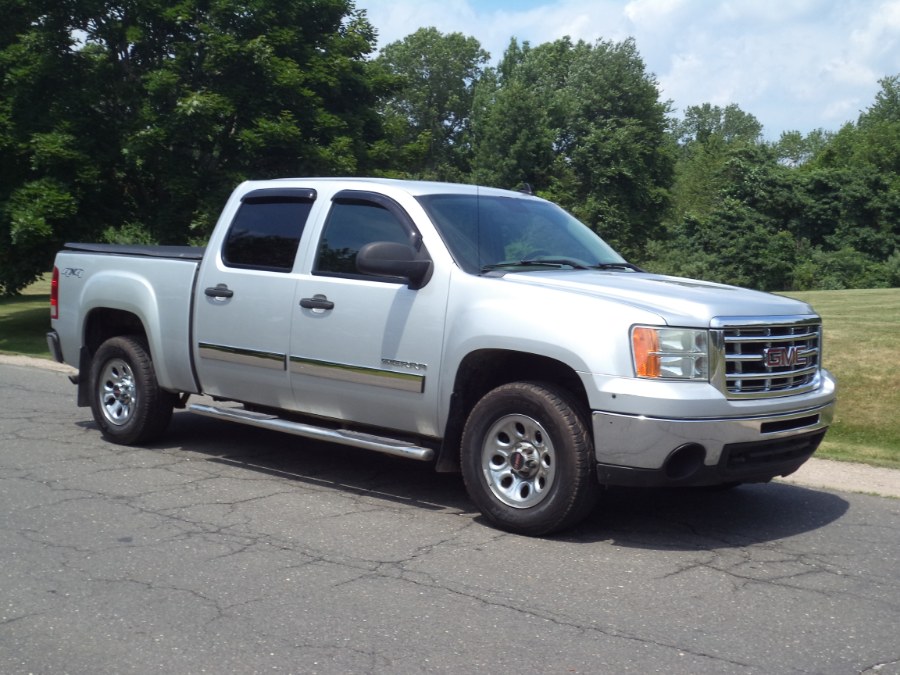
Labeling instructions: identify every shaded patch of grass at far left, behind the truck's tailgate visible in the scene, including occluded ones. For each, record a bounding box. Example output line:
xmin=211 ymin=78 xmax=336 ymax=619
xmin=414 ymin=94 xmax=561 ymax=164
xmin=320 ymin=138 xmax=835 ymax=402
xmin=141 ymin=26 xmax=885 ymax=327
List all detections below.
xmin=0 ymin=274 xmax=50 ymax=359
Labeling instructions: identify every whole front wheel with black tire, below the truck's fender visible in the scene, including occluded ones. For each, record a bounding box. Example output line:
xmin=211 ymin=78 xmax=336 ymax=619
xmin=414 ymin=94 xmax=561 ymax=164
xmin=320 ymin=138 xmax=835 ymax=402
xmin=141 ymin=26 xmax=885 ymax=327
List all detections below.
xmin=460 ymin=382 xmax=600 ymax=536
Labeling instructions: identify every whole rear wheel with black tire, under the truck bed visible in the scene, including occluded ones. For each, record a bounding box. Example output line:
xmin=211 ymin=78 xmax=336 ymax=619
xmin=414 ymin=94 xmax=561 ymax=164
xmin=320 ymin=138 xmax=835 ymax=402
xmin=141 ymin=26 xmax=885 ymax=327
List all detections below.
xmin=90 ymin=336 xmax=176 ymax=445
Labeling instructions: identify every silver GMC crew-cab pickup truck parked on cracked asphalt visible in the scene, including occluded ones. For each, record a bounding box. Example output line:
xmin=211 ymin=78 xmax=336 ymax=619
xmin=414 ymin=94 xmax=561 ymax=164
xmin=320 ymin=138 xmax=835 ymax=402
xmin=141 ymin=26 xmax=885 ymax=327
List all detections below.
xmin=48 ymin=178 xmax=835 ymax=535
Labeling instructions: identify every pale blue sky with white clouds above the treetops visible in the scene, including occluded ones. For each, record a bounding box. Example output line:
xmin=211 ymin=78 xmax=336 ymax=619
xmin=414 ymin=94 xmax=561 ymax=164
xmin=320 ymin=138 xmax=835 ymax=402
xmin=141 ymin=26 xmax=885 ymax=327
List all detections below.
xmin=356 ymin=0 xmax=900 ymax=140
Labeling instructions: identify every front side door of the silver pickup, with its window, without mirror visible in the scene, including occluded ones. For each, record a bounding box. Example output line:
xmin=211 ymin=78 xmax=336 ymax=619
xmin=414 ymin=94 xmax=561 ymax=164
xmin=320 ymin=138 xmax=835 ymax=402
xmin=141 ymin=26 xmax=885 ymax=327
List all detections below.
xmin=290 ymin=190 xmax=448 ymax=435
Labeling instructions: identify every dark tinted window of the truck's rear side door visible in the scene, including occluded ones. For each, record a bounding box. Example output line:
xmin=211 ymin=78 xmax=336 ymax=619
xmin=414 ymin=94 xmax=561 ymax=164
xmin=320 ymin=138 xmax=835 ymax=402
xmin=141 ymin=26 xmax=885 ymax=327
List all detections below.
xmin=222 ymin=198 xmax=312 ymax=272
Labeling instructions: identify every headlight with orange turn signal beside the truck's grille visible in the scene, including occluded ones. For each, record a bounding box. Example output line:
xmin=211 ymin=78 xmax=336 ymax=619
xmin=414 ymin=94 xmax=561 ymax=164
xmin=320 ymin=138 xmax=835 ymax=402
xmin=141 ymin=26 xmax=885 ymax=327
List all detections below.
xmin=631 ymin=326 xmax=709 ymax=380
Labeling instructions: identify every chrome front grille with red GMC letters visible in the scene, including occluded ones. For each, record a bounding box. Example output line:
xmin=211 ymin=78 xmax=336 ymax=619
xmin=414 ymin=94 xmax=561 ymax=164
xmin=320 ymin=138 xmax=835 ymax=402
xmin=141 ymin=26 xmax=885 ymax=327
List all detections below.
xmin=718 ymin=320 xmax=822 ymax=398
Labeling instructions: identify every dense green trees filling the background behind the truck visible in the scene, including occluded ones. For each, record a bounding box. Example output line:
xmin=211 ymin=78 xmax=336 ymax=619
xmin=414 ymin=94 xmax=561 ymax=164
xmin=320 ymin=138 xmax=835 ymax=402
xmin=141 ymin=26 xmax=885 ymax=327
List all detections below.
xmin=0 ymin=0 xmax=900 ymax=294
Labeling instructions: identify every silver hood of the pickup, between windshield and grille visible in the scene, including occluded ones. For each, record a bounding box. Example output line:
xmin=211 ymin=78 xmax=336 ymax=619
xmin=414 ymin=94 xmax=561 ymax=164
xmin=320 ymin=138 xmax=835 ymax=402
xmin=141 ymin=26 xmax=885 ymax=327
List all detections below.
xmin=503 ymin=270 xmax=815 ymax=327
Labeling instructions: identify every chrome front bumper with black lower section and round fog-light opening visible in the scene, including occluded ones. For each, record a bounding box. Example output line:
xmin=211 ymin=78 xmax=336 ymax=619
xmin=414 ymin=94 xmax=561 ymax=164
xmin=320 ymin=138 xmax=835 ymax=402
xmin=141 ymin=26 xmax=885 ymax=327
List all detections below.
xmin=593 ymin=399 xmax=835 ymax=486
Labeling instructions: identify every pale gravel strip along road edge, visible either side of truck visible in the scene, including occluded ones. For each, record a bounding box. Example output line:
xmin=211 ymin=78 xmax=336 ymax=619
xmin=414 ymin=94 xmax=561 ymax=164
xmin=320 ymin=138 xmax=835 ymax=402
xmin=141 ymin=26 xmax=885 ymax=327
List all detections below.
xmin=0 ymin=354 xmax=900 ymax=499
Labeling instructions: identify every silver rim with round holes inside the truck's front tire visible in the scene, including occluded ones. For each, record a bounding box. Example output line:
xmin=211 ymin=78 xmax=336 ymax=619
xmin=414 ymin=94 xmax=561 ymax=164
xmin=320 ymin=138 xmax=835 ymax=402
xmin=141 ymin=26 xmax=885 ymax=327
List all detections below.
xmin=481 ymin=414 xmax=556 ymax=509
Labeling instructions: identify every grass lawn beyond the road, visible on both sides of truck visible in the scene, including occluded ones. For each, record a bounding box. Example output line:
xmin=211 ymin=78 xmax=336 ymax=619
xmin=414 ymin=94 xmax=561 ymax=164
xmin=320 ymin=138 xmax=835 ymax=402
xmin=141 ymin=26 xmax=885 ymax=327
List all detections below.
xmin=0 ymin=275 xmax=900 ymax=469
